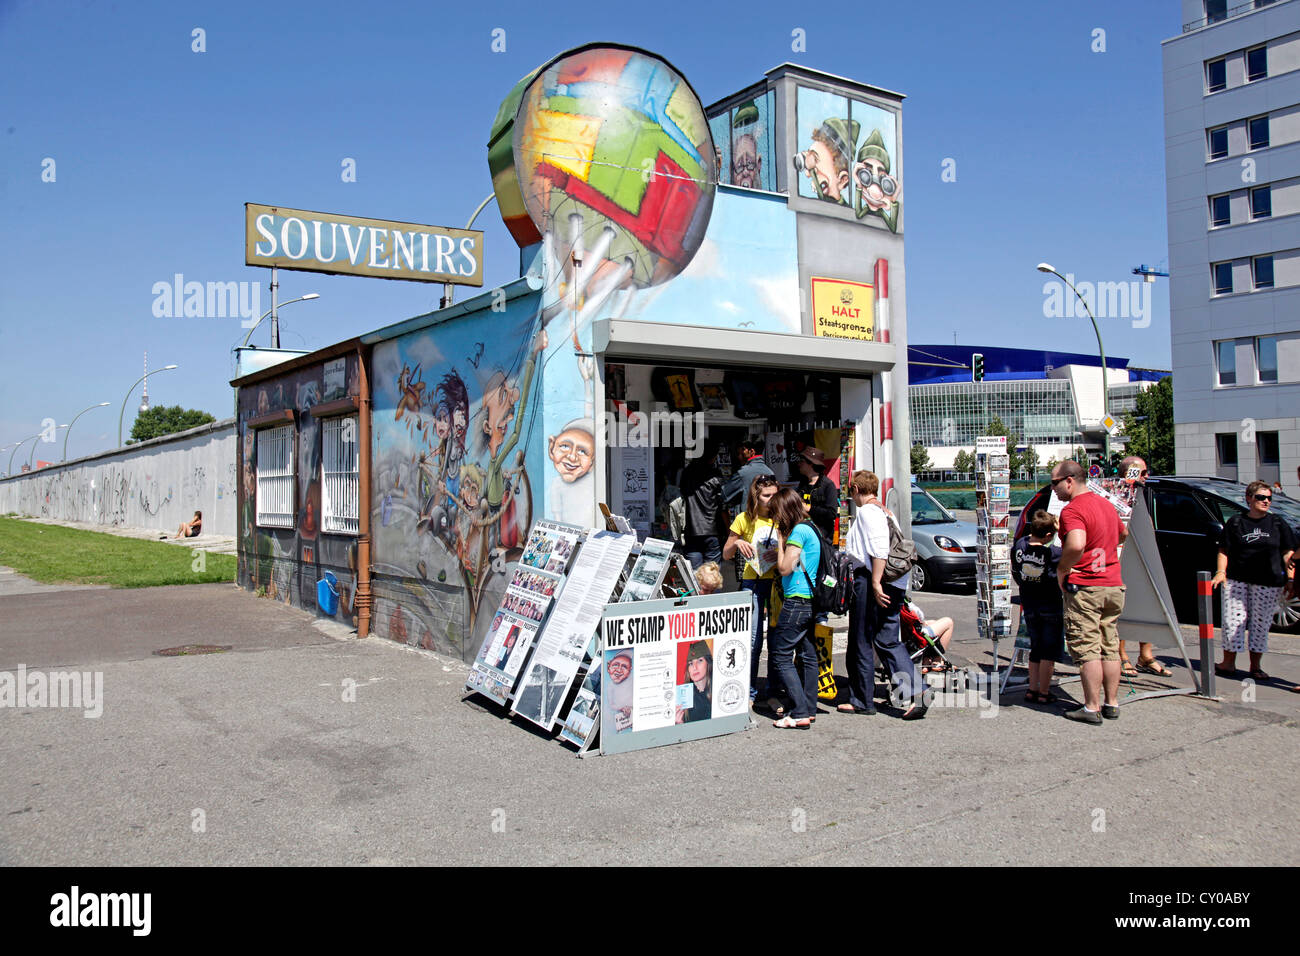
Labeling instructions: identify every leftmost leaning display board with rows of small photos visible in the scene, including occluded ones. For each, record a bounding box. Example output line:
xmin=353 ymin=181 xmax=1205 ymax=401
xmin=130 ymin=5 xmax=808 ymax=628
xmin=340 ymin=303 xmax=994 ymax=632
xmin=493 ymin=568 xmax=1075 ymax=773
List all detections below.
xmin=465 ymin=566 xmax=564 ymax=704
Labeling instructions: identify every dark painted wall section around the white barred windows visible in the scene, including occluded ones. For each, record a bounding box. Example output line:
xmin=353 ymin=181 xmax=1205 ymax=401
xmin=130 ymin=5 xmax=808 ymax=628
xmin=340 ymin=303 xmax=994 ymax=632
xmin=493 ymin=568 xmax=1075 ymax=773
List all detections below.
xmin=238 ymin=355 xmax=360 ymax=622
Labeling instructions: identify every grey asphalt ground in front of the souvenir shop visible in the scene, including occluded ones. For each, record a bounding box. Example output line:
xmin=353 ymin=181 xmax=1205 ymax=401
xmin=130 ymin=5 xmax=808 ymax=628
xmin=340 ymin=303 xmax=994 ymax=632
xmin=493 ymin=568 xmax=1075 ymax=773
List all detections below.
xmin=0 ymin=574 xmax=1300 ymax=866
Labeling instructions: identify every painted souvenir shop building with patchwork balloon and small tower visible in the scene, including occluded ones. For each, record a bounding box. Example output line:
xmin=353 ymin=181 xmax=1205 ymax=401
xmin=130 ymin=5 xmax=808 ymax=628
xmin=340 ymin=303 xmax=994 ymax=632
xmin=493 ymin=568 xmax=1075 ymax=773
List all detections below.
xmin=231 ymin=44 xmax=910 ymax=659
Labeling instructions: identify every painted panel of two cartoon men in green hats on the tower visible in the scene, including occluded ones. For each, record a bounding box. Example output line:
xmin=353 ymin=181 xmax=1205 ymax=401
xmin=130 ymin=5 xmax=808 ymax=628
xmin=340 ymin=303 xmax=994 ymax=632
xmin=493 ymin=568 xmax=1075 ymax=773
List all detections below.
xmin=793 ymin=86 xmax=902 ymax=233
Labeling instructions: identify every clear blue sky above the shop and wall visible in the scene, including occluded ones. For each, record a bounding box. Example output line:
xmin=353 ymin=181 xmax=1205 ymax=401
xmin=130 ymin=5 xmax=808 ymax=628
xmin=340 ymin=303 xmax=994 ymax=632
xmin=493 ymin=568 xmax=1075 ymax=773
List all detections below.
xmin=0 ymin=0 xmax=1180 ymax=468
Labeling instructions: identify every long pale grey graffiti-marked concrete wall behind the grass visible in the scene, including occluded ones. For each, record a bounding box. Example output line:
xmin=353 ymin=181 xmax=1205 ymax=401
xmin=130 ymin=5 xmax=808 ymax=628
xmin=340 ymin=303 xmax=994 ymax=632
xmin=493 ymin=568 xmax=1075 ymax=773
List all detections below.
xmin=0 ymin=419 xmax=237 ymax=536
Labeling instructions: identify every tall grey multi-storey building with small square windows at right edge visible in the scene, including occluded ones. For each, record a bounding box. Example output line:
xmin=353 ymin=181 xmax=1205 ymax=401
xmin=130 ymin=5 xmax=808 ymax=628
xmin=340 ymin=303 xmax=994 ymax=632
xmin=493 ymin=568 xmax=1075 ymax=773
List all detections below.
xmin=1164 ymin=0 xmax=1300 ymax=494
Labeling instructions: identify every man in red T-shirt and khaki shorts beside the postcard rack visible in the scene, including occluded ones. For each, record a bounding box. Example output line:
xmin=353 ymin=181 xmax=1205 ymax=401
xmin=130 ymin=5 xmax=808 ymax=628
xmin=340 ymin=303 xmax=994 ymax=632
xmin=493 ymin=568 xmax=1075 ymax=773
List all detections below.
xmin=1052 ymin=462 xmax=1128 ymax=724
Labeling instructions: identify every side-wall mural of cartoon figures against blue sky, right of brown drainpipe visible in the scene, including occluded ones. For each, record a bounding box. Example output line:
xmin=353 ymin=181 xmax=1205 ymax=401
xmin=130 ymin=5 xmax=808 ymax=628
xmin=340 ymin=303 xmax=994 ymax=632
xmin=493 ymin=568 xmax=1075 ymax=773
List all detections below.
xmin=371 ymin=295 xmax=547 ymax=654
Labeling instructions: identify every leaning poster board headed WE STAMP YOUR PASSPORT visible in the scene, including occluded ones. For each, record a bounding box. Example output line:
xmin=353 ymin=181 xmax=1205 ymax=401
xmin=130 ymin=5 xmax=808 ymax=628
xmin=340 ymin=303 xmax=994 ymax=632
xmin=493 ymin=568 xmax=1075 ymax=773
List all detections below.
xmin=590 ymin=592 xmax=754 ymax=753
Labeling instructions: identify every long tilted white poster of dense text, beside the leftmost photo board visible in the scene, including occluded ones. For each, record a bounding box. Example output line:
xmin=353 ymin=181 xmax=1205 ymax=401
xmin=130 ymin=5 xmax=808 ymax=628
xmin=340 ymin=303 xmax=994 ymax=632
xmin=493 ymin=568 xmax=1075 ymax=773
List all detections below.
xmin=514 ymin=529 xmax=637 ymax=730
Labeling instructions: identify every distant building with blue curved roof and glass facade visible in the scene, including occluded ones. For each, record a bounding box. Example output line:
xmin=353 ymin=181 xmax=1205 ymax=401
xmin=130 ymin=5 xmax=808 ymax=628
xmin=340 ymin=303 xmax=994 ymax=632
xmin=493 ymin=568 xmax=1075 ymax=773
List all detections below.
xmin=907 ymin=345 xmax=1169 ymax=470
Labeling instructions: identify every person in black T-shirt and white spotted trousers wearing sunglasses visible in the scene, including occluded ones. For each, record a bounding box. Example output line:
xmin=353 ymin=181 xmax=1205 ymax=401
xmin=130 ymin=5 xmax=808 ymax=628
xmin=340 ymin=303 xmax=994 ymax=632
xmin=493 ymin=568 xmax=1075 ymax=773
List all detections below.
xmin=1210 ymin=481 xmax=1296 ymax=683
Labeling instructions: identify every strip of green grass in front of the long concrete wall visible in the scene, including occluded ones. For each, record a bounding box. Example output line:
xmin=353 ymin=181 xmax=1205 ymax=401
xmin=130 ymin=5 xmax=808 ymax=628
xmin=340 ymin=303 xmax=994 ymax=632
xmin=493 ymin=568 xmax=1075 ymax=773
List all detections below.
xmin=0 ymin=518 xmax=237 ymax=588
